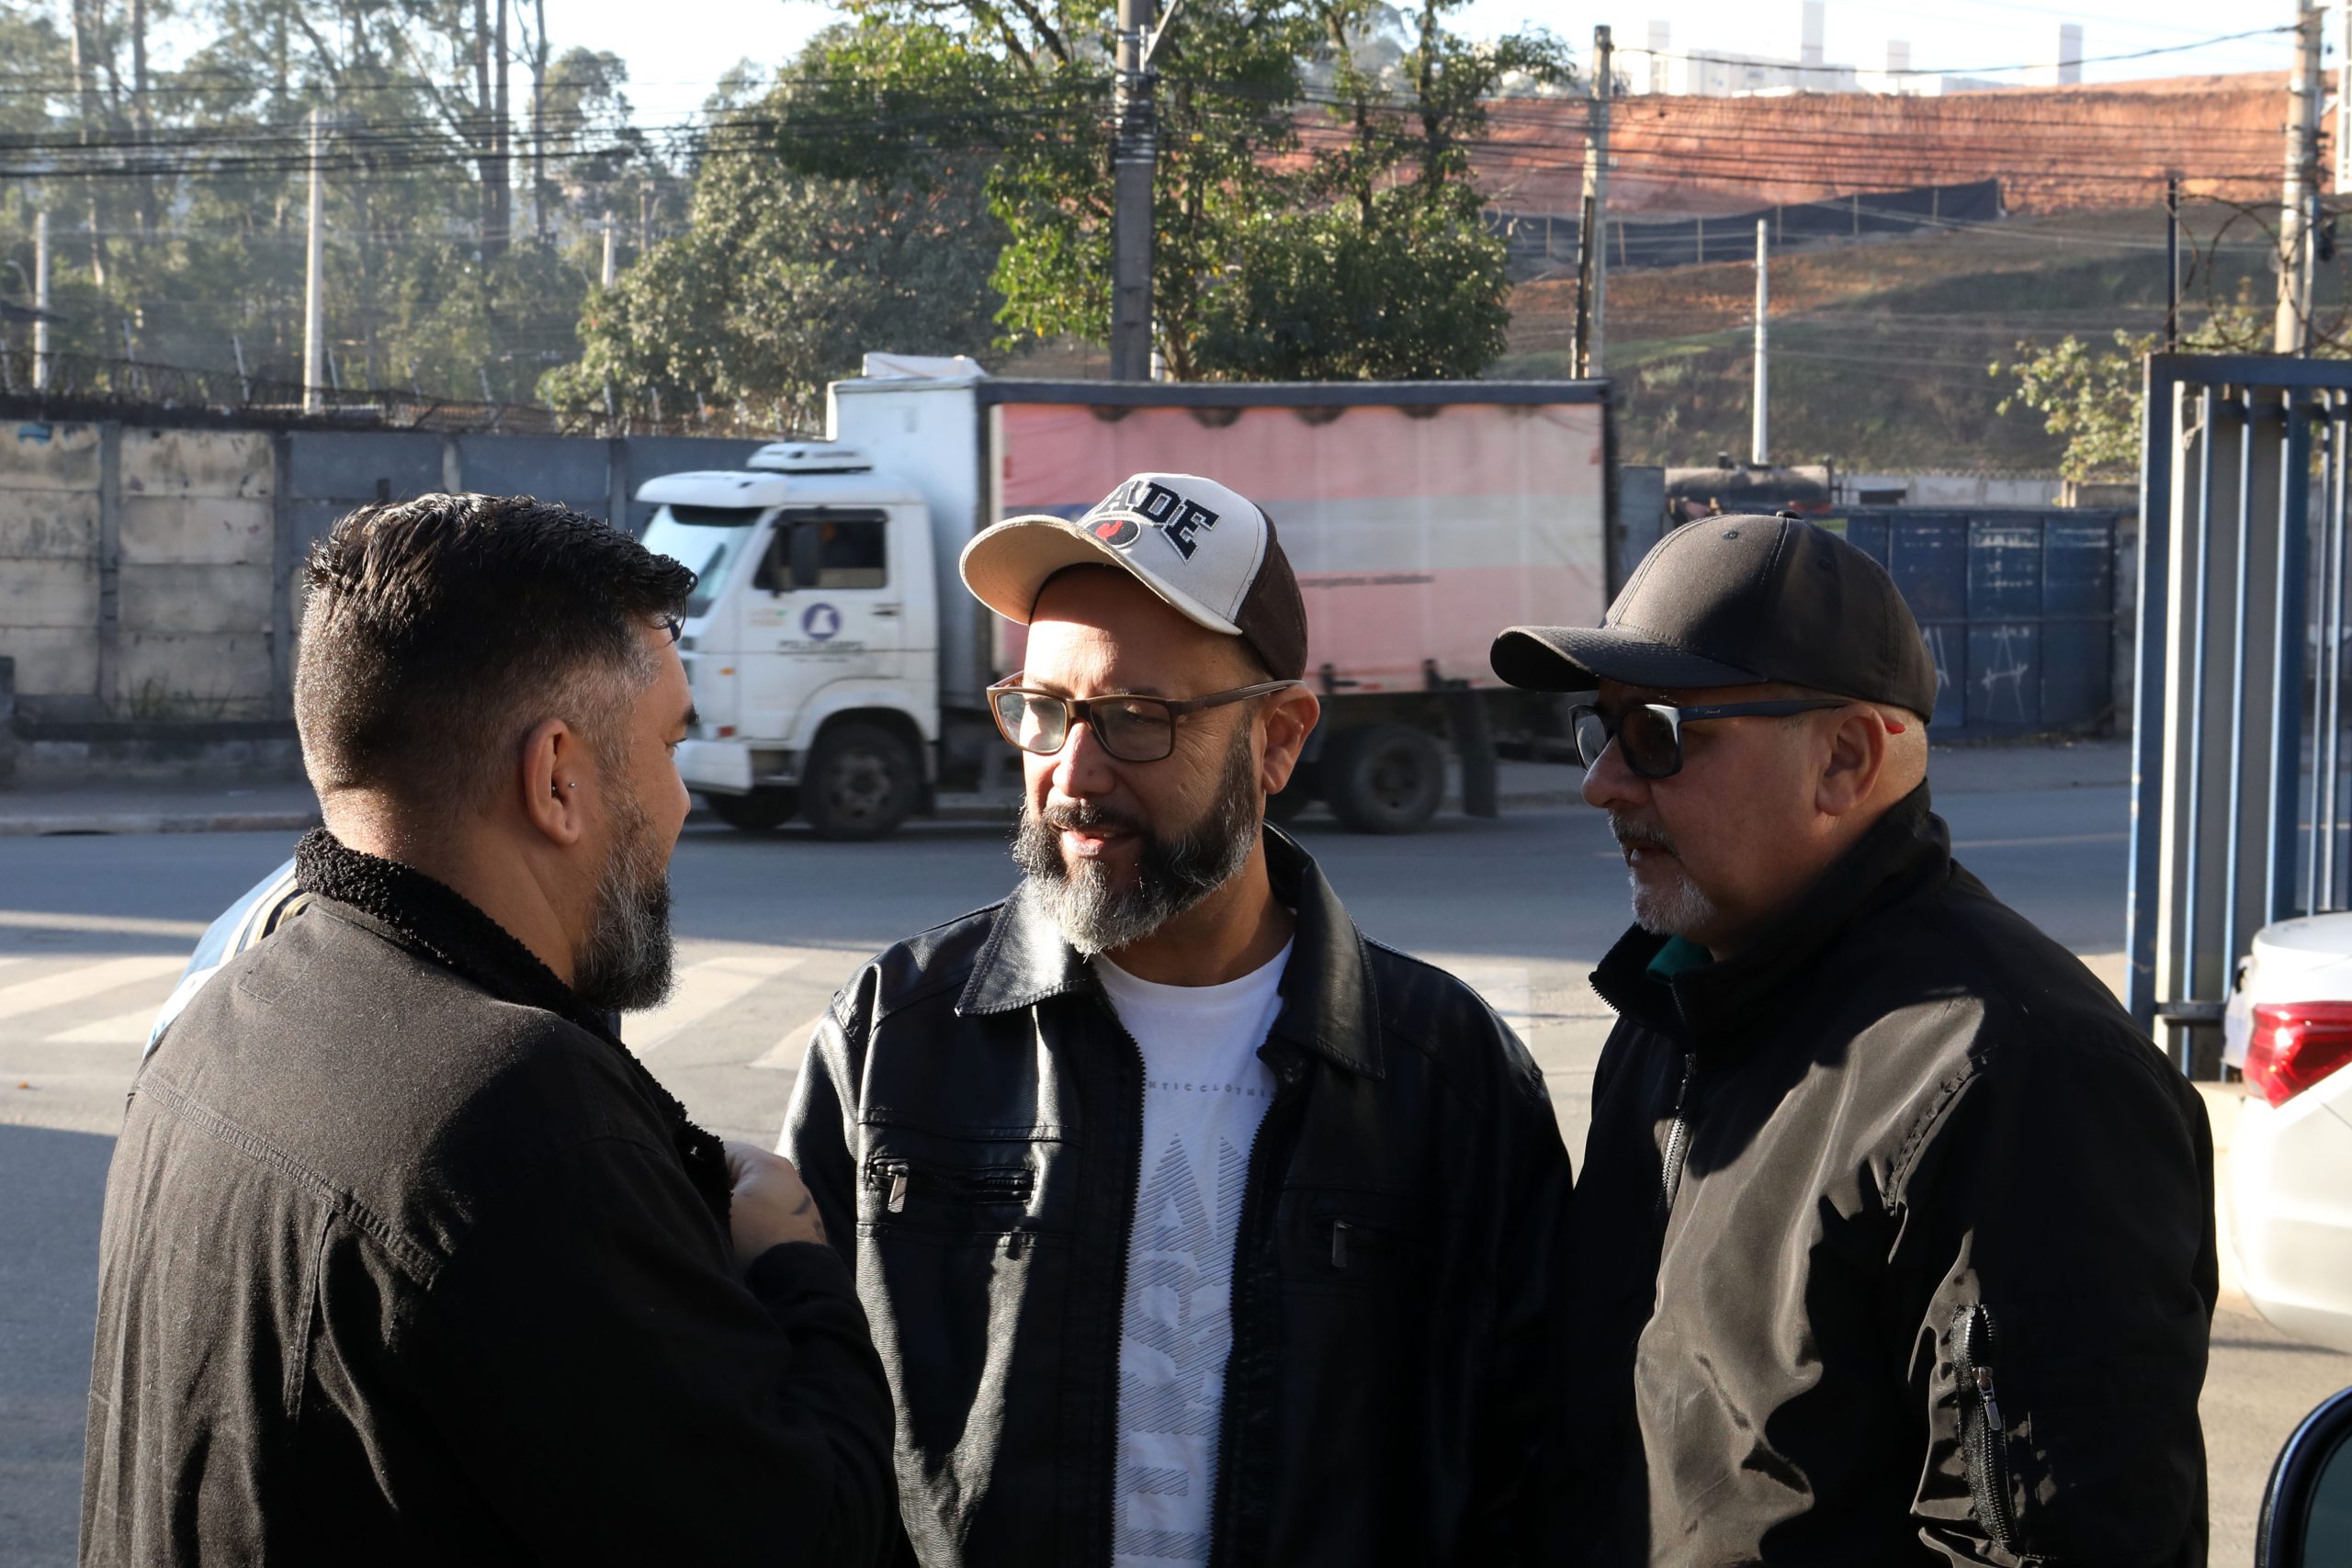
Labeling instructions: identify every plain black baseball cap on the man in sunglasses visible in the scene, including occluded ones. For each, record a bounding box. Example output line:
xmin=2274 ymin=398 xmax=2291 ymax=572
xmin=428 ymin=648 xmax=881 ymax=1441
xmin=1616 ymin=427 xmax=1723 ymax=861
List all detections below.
xmin=1488 ymin=517 xmax=1936 ymax=719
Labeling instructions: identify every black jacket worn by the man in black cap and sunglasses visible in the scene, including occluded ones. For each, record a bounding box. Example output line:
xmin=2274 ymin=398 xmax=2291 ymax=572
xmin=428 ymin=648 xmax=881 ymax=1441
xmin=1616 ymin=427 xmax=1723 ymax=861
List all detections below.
xmin=1576 ymin=785 xmax=2216 ymax=1568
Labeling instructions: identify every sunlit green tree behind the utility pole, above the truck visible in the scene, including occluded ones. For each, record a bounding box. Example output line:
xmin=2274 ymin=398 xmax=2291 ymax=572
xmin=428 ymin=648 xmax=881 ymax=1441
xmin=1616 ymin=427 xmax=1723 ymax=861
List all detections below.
xmin=752 ymin=0 xmax=1569 ymax=378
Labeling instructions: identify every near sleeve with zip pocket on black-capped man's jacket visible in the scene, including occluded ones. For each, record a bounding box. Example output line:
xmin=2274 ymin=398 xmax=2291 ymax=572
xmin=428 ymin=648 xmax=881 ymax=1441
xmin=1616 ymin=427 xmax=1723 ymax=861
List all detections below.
xmin=1895 ymin=1030 xmax=2218 ymax=1568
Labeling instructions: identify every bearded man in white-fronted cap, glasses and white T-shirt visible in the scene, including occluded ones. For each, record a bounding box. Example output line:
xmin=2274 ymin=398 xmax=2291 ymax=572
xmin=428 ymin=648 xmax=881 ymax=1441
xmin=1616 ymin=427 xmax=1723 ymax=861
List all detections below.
xmin=783 ymin=475 xmax=1571 ymax=1568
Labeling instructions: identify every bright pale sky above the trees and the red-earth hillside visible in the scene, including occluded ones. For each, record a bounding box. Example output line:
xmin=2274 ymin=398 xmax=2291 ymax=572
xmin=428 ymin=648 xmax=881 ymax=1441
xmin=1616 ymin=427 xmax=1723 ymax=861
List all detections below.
xmin=548 ymin=0 xmax=2335 ymax=125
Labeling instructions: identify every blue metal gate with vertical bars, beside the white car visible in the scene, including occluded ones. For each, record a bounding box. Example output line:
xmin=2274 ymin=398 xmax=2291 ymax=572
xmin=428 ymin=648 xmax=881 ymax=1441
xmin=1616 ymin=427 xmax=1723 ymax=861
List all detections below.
xmin=2124 ymin=355 xmax=2352 ymax=1069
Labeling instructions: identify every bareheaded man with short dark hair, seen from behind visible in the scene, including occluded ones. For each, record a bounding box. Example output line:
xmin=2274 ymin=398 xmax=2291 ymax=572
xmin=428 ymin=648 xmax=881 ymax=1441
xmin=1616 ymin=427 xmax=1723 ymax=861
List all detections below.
xmin=83 ymin=496 xmax=899 ymax=1568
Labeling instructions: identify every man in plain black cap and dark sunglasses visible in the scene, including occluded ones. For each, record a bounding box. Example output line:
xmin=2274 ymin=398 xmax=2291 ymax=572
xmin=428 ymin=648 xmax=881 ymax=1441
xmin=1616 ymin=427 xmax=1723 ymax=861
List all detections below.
xmin=1494 ymin=517 xmax=2216 ymax=1568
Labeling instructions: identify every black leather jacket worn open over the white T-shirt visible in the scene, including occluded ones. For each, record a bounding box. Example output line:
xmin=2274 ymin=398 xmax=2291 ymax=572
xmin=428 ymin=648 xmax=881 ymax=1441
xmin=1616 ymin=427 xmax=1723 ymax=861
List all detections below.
xmin=786 ymin=829 xmax=1569 ymax=1568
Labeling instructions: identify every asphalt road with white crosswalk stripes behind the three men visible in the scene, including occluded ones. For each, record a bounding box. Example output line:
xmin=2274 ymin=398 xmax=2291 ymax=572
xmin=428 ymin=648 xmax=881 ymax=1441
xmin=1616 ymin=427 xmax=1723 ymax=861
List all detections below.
xmin=0 ymin=787 xmax=2352 ymax=1568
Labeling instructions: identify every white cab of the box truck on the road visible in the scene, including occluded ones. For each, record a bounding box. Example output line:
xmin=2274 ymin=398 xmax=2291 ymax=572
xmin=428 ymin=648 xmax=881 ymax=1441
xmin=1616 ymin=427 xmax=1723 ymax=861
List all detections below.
xmin=638 ymin=442 xmax=938 ymax=837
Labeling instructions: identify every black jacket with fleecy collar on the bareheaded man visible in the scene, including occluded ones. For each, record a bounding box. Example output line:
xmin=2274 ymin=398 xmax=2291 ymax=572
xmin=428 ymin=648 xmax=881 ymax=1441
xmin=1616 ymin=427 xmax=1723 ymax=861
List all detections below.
xmin=83 ymin=832 xmax=896 ymax=1568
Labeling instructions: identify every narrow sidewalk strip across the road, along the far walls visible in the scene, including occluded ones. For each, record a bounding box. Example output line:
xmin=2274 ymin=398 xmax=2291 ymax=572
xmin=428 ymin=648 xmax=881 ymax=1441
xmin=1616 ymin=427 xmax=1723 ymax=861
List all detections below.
xmin=0 ymin=740 xmax=2131 ymax=837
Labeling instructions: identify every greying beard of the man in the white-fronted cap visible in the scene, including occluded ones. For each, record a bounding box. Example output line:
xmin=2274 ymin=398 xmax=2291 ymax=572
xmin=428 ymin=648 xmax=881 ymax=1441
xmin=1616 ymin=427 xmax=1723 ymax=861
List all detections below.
xmin=1013 ymin=724 xmax=1261 ymax=959
